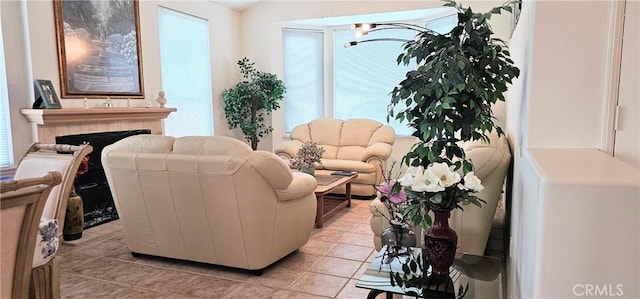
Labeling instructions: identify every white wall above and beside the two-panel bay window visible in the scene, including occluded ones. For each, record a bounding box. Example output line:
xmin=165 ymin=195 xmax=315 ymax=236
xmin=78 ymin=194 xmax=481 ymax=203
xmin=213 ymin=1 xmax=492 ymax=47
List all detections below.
xmin=242 ymin=0 xmax=510 ymax=152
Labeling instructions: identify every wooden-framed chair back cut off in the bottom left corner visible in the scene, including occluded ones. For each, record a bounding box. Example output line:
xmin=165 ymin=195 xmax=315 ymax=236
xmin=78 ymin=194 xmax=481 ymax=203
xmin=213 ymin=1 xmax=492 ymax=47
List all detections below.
xmin=0 ymin=172 xmax=62 ymax=298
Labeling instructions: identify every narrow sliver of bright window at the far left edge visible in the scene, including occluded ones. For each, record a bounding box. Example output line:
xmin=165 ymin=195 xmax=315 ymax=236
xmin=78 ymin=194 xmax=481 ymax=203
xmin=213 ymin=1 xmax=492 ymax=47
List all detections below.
xmin=0 ymin=19 xmax=13 ymax=168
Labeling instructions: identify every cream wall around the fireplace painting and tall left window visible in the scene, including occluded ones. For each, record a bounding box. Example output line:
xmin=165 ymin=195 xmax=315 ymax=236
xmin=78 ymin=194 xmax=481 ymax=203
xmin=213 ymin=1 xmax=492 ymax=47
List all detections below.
xmin=0 ymin=0 xmax=242 ymax=163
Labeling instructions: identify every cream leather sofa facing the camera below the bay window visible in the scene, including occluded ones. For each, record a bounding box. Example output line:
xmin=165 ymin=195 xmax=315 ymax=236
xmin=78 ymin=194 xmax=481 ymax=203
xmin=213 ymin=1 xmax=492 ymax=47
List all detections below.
xmin=274 ymin=118 xmax=395 ymax=196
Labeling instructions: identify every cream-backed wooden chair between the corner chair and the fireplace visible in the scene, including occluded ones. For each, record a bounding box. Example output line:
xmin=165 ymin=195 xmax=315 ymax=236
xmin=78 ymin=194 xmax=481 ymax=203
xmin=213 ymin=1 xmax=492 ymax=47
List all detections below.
xmin=15 ymin=143 xmax=93 ymax=298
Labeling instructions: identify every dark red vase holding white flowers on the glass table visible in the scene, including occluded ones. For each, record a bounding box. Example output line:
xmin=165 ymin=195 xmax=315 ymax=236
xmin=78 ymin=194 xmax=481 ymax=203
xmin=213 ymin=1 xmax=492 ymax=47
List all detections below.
xmin=423 ymin=209 xmax=458 ymax=275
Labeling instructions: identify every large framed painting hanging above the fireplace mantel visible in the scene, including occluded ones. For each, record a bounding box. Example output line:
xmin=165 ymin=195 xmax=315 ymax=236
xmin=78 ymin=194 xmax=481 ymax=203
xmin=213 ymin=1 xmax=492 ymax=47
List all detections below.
xmin=53 ymin=0 xmax=144 ymax=98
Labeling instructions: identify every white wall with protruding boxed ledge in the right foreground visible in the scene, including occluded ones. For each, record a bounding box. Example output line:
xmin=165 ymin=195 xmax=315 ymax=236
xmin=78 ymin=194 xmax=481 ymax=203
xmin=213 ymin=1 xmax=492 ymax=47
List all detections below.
xmin=507 ymin=1 xmax=640 ymax=298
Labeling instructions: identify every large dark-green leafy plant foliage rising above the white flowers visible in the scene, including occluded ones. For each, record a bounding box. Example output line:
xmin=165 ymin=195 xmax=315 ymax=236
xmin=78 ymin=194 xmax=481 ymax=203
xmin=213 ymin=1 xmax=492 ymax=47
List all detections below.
xmin=387 ymin=0 xmax=520 ymax=173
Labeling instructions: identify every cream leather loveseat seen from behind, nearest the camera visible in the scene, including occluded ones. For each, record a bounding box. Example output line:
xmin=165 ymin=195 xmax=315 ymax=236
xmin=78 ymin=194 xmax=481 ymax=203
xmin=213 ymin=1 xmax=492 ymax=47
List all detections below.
xmin=102 ymin=135 xmax=316 ymax=274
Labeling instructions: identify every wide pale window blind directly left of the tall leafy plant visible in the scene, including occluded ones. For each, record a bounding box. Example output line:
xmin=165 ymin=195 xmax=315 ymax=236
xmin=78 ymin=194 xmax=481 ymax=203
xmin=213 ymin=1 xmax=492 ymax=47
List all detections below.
xmin=333 ymin=29 xmax=416 ymax=136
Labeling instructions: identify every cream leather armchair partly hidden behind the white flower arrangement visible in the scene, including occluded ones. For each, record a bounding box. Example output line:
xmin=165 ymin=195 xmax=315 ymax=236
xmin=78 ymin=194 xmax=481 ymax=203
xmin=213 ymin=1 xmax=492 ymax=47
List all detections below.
xmin=370 ymin=132 xmax=511 ymax=255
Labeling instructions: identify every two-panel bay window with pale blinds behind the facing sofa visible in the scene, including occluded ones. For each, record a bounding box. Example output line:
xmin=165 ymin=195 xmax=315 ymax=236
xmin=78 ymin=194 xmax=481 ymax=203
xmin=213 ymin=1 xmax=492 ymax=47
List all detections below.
xmin=283 ymin=14 xmax=457 ymax=136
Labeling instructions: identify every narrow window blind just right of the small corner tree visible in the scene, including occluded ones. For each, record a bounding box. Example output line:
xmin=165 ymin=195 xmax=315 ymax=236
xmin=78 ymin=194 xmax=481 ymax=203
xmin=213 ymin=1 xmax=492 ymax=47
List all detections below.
xmin=282 ymin=29 xmax=324 ymax=133
